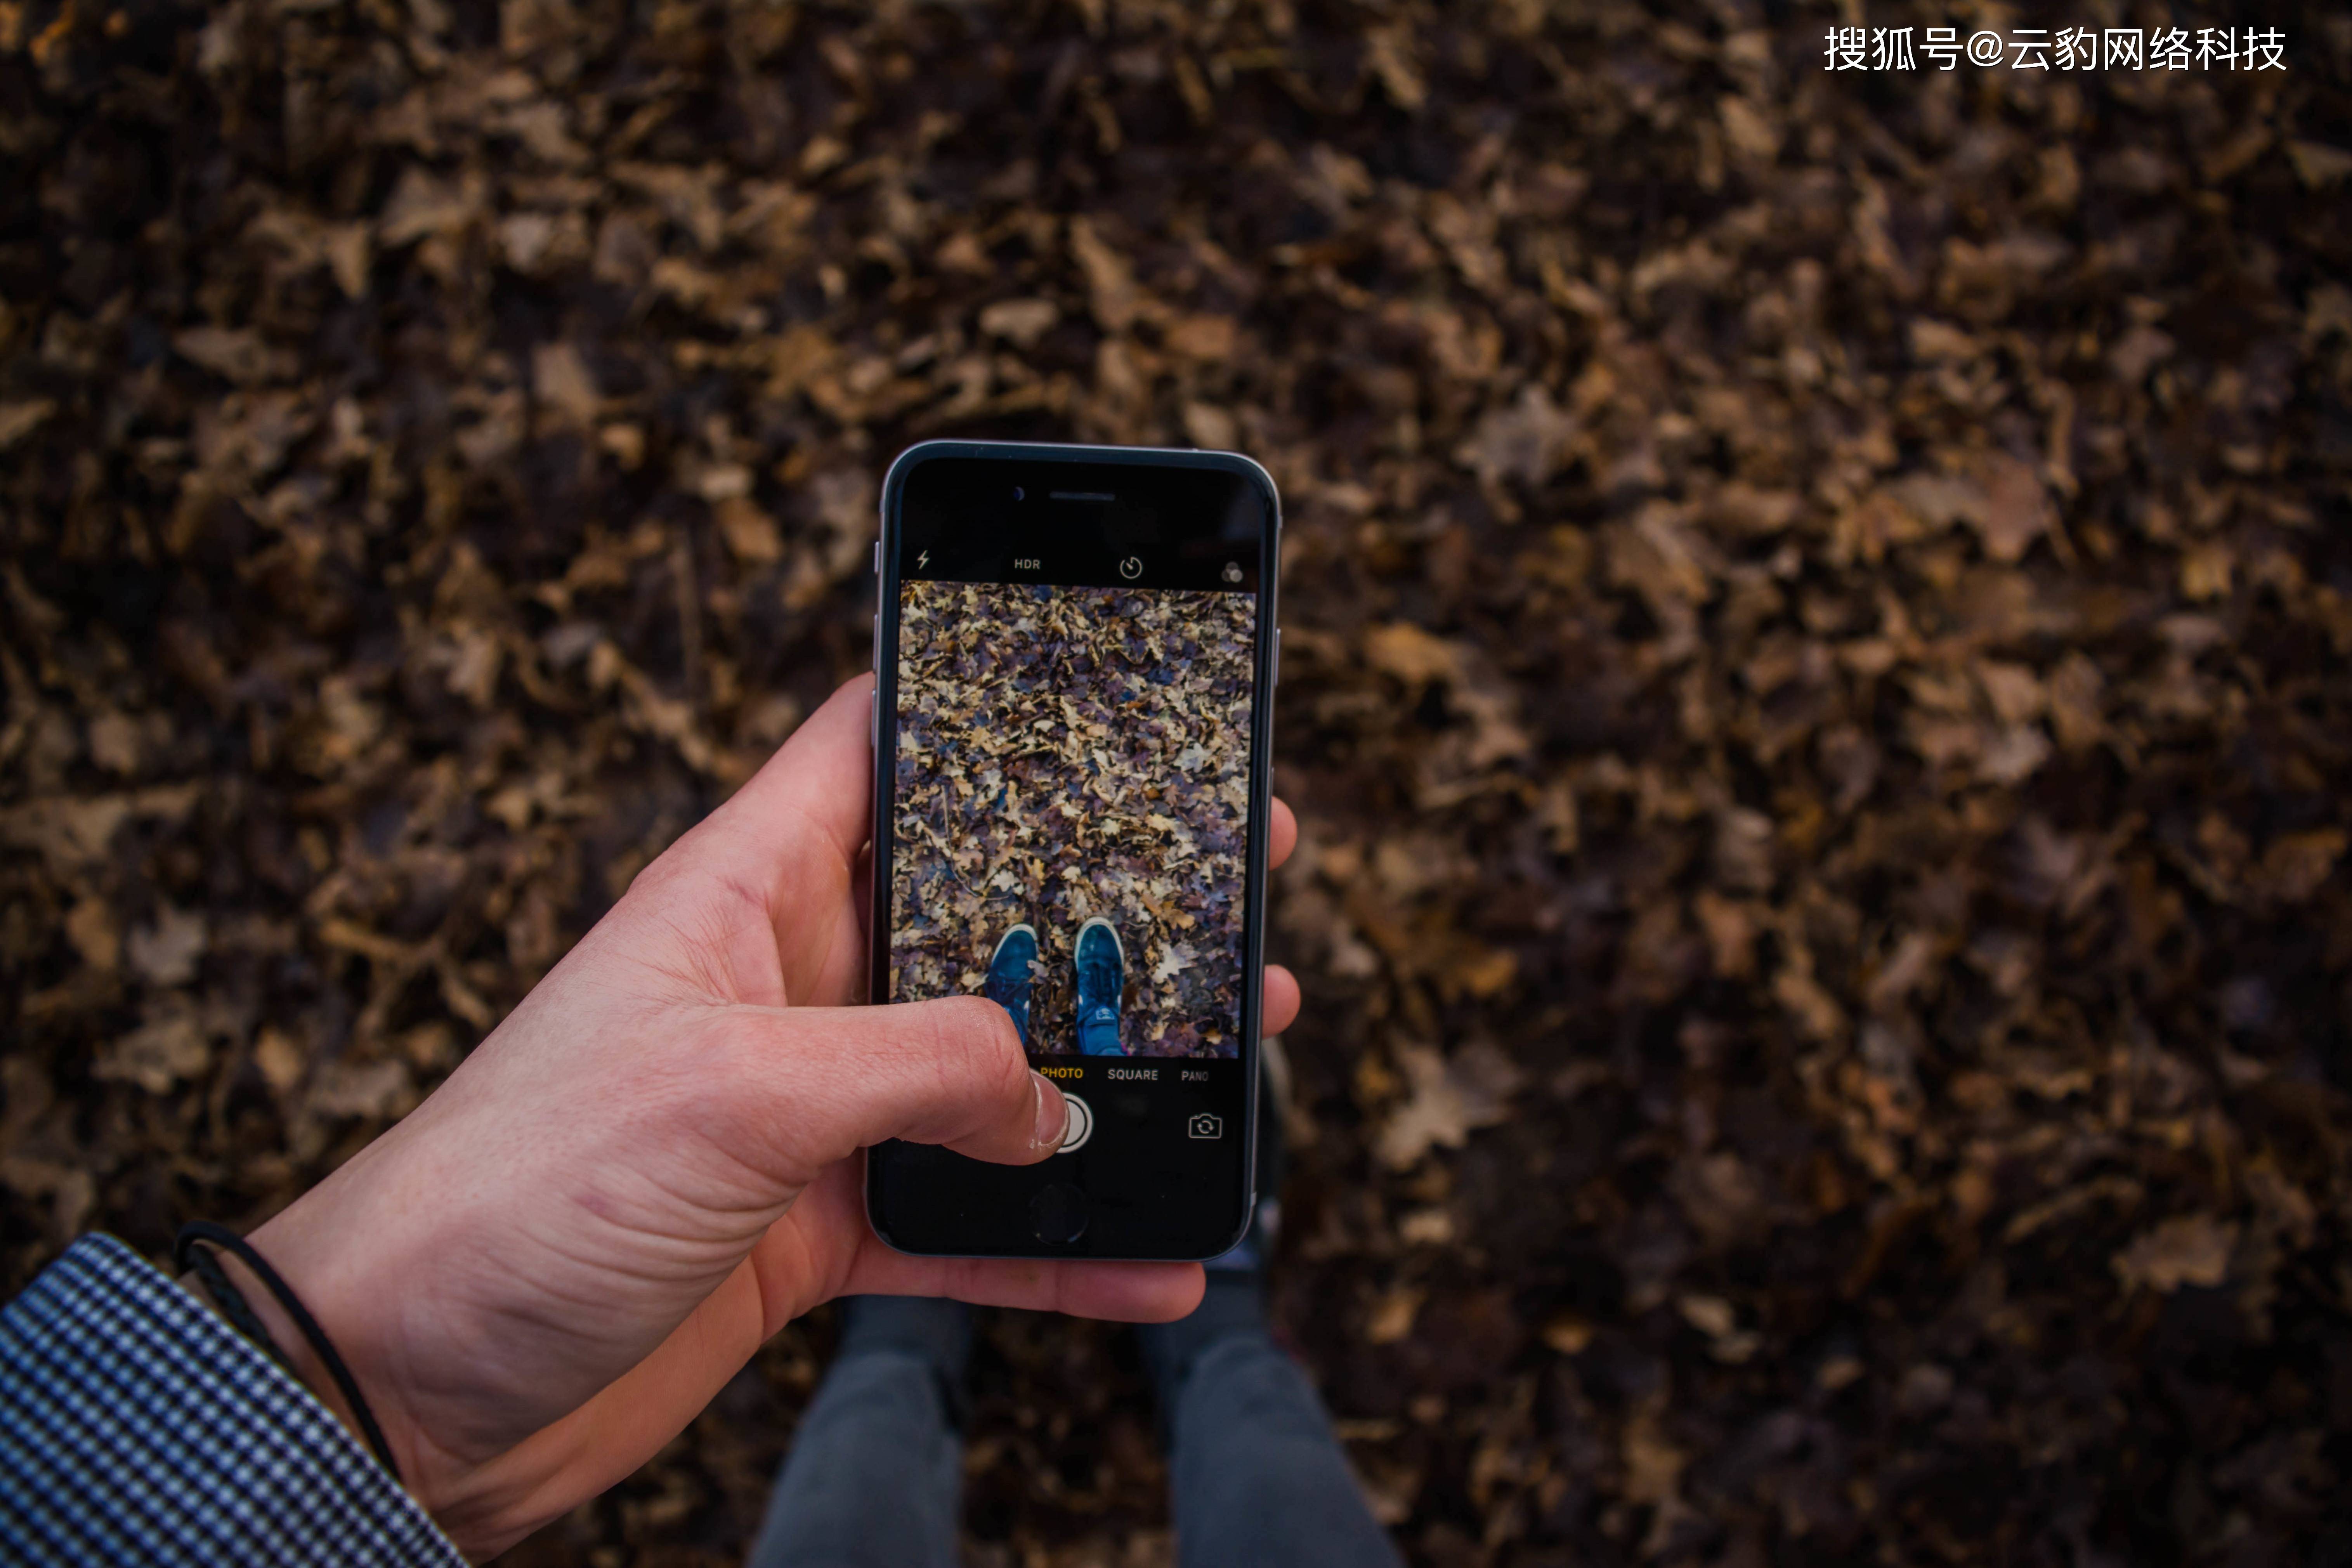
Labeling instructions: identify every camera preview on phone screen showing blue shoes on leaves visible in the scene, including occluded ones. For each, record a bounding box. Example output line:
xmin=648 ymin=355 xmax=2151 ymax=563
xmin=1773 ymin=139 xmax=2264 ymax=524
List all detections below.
xmin=889 ymin=583 xmax=1256 ymax=1056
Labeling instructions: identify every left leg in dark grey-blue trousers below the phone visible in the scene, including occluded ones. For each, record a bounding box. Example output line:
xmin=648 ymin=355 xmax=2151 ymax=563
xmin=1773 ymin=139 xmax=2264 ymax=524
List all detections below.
xmin=748 ymin=1295 xmax=971 ymax=1568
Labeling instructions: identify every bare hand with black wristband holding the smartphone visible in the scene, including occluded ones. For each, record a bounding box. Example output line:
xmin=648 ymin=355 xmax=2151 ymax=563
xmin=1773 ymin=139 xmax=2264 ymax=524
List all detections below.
xmin=224 ymin=679 xmax=1298 ymax=1556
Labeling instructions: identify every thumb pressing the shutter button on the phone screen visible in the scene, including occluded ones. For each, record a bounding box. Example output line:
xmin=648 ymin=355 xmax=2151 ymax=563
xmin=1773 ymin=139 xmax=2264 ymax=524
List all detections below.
xmin=741 ymin=997 xmax=1070 ymax=1175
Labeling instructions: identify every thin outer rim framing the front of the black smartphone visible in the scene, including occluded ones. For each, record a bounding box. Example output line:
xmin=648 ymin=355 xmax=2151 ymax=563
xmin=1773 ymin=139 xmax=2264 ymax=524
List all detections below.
xmin=866 ymin=440 xmax=1282 ymax=1263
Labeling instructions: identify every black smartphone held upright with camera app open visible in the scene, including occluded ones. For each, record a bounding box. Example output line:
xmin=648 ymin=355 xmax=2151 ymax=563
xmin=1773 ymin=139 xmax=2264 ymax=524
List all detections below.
xmin=866 ymin=442 xmax=1282 ymax=1258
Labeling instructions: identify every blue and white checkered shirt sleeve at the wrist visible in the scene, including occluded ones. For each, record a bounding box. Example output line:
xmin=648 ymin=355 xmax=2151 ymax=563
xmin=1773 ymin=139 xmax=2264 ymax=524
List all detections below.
xmin=0 ymin=1237 xmax=466 ymax=1568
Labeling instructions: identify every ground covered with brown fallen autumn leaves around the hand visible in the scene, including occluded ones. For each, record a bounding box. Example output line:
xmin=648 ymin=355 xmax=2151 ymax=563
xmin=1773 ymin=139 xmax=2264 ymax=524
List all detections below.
xmin=0 ymin=0 xmax=2352 ymax=1568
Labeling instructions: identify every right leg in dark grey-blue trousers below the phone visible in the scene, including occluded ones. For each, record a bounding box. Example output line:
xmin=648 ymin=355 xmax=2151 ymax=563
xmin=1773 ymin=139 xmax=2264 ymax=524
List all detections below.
xmin=1143 ymin=1274 xmax=1402 ymax=1568
